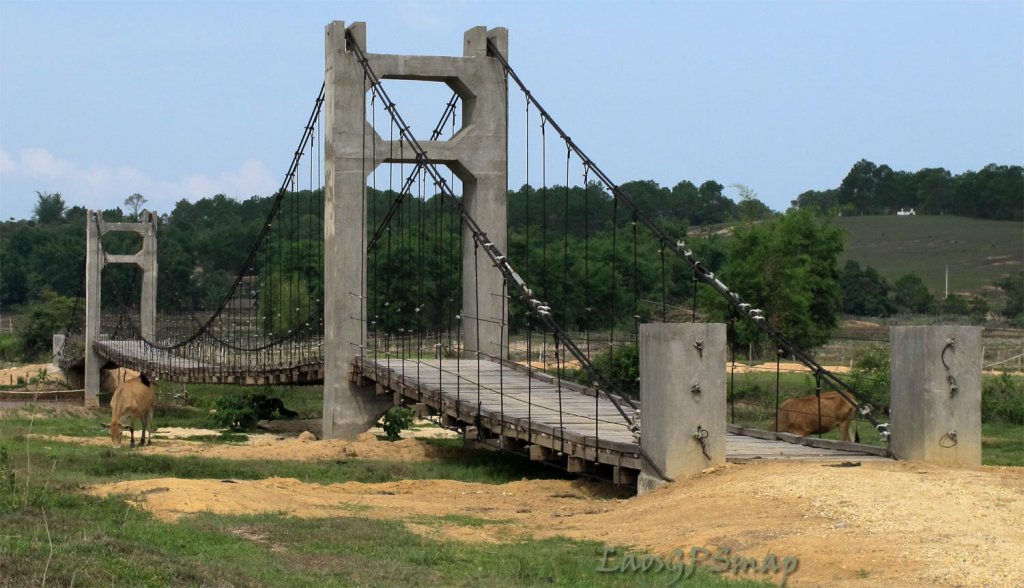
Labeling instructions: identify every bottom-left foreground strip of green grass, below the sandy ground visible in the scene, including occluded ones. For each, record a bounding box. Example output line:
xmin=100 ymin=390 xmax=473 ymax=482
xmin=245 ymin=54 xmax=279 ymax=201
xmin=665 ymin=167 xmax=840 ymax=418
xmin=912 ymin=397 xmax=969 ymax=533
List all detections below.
xmin=0 ymin=487 xmax=770 ymax=586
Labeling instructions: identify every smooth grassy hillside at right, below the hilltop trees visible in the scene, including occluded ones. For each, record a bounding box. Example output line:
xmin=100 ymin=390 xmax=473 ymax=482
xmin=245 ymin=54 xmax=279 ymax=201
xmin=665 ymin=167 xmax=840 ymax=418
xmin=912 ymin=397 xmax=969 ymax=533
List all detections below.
xmin=836 ymin=215 xmax=1024 ymax=309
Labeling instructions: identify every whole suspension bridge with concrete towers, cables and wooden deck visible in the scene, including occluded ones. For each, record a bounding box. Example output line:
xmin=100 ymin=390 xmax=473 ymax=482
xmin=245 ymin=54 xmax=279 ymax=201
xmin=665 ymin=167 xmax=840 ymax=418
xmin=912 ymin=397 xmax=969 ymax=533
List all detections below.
xmin=49 ymin=23 xmax=921 ymax=491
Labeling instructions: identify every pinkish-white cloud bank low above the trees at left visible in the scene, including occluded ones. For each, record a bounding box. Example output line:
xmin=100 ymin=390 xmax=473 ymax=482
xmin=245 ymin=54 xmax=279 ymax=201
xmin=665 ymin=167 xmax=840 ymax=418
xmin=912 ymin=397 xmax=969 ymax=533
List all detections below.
xmin=0 ymin=148 xmax=280 ymax=218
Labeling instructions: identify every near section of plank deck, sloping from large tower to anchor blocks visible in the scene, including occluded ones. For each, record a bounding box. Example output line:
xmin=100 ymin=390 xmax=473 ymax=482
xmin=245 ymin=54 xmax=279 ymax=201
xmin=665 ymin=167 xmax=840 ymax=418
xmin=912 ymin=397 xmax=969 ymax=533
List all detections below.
xmin=353 ymin=358 xmax=887 ymax=484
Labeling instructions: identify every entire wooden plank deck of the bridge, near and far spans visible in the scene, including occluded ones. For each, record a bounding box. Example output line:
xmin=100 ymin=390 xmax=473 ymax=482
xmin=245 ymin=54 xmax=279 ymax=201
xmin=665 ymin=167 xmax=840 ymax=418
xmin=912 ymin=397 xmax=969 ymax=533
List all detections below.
xmin=88 ymin=340 xmax=887 ymax=485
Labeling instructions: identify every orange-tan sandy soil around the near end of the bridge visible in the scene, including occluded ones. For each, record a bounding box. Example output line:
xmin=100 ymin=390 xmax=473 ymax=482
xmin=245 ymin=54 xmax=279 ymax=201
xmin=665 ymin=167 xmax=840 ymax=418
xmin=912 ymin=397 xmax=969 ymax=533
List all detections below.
xmin=81 ymin=435 xmax=1024 ymax=586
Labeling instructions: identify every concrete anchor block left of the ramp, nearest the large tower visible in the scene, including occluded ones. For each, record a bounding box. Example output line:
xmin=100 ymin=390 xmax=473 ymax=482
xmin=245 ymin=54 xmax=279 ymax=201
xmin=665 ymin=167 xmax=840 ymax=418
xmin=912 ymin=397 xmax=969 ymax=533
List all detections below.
xmin=637 ymin=323 xmax=726 ymax=495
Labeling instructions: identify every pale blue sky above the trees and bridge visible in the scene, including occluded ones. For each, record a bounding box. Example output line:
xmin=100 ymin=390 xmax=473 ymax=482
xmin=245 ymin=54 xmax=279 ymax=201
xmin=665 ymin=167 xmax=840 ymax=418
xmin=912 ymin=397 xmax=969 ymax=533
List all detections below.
xmin=0 ymin=0 xmax=1024 ymax=219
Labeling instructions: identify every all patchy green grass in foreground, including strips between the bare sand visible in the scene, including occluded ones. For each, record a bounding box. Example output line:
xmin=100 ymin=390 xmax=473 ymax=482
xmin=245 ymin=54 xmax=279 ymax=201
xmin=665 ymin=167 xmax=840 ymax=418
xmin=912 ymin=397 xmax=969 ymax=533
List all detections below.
xmin=0 ymin=401 xmax=762 ymax=587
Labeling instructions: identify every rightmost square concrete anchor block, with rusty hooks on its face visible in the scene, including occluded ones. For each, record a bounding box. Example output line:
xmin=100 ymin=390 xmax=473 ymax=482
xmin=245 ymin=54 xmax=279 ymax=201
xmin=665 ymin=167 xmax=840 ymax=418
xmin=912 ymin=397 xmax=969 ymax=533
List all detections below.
xmin=890 ymin=326 xmax=982 ymax=465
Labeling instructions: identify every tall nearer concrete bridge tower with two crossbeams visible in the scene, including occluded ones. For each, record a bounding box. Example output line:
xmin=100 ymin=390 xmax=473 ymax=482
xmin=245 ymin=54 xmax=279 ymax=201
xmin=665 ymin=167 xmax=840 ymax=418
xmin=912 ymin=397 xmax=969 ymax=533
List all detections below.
xmin=324 ymin=22 xmax=508 ymax=438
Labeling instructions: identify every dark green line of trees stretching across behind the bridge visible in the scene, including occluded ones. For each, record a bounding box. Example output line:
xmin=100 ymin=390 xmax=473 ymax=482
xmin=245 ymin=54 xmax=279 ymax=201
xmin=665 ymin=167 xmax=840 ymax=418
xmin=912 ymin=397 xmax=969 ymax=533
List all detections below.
xmin=0 ymin=162 xmax=1024 ymax=364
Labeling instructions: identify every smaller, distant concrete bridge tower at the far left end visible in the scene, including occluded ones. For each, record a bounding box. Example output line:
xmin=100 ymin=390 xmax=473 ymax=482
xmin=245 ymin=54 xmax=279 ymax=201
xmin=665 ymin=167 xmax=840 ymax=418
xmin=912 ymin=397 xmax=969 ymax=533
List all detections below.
xmin=84 ymin=210 xmax=157 ymax=407
